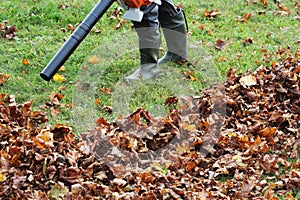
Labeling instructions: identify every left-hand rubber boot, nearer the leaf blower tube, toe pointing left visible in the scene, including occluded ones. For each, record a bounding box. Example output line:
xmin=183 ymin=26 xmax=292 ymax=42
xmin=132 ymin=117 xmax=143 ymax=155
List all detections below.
xmin=125 ymin=27 xmax=160 ymax=81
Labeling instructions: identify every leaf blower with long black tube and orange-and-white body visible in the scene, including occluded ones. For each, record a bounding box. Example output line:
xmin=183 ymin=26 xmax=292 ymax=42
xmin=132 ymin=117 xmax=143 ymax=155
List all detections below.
xmin=40 ymin=0 xmax=161 ymax=81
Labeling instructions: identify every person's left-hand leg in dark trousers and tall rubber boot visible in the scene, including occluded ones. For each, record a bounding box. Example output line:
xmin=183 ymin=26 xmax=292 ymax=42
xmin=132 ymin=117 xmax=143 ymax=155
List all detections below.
xmin=125 ymin=6 xmax=160 ymax=80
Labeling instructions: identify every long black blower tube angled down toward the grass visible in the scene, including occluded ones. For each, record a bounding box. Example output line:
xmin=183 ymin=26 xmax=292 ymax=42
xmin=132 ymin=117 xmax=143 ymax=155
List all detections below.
xmin=40 ymin=0 xmax=115 ymax=81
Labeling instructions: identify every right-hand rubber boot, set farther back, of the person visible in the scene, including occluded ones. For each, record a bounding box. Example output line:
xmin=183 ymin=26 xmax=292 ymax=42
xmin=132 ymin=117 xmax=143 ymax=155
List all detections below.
xmin=158 ymin=8 xmax=187 ymax=64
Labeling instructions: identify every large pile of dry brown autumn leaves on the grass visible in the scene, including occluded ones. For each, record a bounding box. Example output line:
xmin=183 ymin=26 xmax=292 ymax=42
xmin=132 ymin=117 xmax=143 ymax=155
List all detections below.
xmin=0 ymin=54 xmax=300 ymax=199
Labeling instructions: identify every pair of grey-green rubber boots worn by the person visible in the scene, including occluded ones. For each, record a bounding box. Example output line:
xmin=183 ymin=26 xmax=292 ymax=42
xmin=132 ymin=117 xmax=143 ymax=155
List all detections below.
xmin=125 ymin=10 xmax=187 ymax=81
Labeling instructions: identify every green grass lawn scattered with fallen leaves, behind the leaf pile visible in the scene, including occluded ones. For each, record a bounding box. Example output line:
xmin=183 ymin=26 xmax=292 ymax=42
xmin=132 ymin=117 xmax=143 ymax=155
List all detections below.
xmin=0 ymin=0 xmax=300 ymax=198
